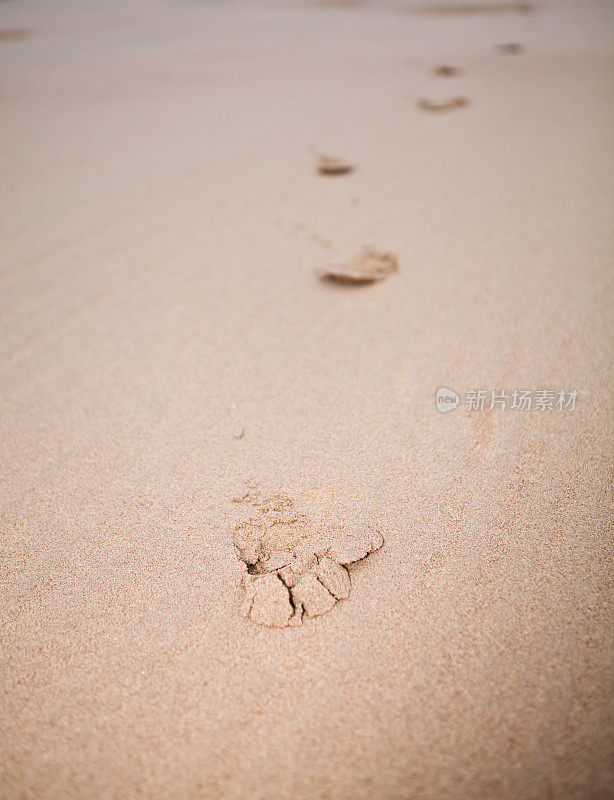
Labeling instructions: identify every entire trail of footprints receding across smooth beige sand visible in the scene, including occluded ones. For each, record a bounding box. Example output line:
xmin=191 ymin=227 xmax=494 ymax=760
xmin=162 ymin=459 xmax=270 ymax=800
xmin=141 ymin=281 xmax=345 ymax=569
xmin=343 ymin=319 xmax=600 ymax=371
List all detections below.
xmin=233 ymin=21 xmax=523 ymax=628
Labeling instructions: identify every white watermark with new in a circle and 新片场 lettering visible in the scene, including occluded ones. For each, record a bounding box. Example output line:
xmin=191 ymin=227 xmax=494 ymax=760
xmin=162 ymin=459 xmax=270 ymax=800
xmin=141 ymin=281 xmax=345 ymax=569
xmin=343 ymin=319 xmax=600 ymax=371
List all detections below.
xmin=435 ymin=386 xmax=579 ymax=413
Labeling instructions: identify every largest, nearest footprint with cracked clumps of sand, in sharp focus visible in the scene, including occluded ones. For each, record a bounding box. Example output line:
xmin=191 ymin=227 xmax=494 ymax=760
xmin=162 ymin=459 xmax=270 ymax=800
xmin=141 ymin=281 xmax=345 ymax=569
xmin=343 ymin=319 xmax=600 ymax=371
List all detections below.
xmin=233 ymin=490 xmax=384 ymax=628
